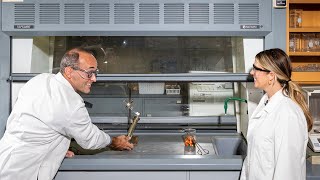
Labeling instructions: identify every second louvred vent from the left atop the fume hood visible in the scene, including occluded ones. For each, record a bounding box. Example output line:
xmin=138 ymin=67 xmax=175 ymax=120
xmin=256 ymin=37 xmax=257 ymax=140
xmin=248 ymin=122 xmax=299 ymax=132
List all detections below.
xmin=39 ymin=4 xmax=60 ymax=24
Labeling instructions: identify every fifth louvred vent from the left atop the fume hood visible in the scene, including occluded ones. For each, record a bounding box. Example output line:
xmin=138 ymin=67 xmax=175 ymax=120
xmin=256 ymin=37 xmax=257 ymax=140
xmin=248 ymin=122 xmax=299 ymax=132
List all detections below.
xmin=114 ymin=4 xmax=134 ymax=24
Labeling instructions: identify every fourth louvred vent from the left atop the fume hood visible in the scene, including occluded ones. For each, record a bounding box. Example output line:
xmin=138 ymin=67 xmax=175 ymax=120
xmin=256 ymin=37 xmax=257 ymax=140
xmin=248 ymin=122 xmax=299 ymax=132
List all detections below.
xmin=89 ymin=4 xmax=110 ymax=24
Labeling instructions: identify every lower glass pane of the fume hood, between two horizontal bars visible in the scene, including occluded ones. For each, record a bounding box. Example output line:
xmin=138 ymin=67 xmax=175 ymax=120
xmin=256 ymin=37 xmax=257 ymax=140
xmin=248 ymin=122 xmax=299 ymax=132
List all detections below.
xmin=82 ymin=82 xmax=235 ymax=117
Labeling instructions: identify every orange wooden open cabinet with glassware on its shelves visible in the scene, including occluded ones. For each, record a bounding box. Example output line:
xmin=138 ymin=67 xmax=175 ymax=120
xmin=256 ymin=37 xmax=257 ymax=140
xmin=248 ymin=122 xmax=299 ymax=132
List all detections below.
xmin=287 ymin=0 xmax=320 ymax=85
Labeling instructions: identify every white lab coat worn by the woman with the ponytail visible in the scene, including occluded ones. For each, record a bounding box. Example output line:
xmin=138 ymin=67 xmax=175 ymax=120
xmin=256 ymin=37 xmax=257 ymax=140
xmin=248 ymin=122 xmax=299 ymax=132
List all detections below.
xmin=240 ymin=90 xmax=308 ymax=180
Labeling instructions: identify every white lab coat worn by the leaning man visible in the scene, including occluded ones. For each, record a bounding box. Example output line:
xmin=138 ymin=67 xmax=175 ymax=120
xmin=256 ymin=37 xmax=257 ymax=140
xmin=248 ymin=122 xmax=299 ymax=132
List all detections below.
xmin=0 ymin=73 xmax=111 ymax=180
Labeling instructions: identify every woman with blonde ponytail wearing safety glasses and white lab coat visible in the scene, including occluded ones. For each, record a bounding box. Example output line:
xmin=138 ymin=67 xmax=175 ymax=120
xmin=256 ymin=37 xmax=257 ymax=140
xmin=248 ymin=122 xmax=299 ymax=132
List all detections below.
xmin=240 ymin=49 xmax=312 ymax=180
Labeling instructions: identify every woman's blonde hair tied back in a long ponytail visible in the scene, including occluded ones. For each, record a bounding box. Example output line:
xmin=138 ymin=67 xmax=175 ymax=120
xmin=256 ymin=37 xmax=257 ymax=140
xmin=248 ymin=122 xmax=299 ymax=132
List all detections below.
xmin=256 ymin=48 xmax=313 ymax=131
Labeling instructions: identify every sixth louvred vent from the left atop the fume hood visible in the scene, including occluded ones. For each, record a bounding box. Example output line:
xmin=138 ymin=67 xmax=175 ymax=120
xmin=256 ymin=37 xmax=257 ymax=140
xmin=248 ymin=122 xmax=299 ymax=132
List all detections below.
xmin=139 ymin=4 xmax=160 ymax=24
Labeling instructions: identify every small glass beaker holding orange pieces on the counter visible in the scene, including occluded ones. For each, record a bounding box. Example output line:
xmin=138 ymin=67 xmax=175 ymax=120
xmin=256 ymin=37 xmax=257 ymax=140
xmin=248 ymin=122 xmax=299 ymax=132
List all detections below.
xmin=183 ymin=128 xmax=196 ymax=155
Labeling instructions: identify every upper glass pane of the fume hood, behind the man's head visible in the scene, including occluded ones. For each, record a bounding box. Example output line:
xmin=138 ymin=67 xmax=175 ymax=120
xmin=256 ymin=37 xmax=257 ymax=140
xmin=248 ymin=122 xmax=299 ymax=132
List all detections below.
xmin=12 ymin=36 xmax=263 ymax=74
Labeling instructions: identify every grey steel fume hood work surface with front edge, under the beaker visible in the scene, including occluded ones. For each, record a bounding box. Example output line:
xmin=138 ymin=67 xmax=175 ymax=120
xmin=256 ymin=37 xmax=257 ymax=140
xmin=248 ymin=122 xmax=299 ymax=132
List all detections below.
xmin=60 ymin=134 xmax=246 ymax=171
